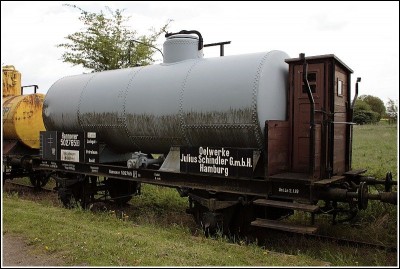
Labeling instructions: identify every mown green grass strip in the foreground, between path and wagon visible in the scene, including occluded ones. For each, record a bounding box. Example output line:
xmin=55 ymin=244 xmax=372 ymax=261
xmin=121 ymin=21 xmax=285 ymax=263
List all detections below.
xmin=3 ymin=194 xmax=326 ymax=266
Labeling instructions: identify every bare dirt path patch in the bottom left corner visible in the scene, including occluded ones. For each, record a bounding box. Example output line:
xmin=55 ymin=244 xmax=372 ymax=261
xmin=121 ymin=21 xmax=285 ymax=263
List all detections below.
xmin=1 ymin=234 xmax=64 ymax=267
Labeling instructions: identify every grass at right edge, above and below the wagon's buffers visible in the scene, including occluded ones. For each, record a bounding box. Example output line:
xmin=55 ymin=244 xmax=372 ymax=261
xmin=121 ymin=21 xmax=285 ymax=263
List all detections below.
xmin=346 ymin=122 xmax=399 ymax=249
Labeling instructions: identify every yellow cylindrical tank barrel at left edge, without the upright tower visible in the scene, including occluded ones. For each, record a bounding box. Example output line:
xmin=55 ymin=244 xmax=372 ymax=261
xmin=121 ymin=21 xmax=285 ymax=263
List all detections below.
xmin=3 ymin=93 xmax=45 ymax=149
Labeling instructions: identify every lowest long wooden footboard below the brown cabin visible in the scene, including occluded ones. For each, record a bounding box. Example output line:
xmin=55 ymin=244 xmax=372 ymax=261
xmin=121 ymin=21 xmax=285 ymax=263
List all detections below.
xmin=251 ymin=219 xmax=318 ymax=234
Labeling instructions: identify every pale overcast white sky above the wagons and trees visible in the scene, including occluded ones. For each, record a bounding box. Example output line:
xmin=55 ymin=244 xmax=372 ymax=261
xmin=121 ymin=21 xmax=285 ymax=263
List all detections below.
xmin=1 ymin=1 xmax=399 ymax=104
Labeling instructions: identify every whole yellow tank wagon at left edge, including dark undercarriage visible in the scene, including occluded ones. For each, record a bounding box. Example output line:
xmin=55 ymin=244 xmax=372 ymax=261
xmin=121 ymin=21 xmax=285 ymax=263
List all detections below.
xmin=2 ymin=65 xmax=47 ymax=186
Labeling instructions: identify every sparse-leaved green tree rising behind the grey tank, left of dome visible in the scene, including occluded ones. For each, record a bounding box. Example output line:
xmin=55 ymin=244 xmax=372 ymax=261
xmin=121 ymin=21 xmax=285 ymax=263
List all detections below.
xmin=57 ymin=4 xmax=171 ymax=72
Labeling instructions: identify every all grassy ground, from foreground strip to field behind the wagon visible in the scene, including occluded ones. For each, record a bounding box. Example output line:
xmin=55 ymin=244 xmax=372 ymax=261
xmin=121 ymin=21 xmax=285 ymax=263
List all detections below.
xmin=3 ymin=122 xmax=398 ymax=266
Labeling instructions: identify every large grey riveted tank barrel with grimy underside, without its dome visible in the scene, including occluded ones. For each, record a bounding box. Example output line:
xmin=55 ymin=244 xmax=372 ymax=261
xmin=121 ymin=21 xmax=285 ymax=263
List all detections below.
xmin=43 ymin=35 xmax=288 ymax=153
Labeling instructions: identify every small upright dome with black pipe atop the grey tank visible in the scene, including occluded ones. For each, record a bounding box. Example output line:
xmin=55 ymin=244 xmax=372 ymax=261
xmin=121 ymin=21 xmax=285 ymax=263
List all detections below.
xmin=163 ymin=30 xmax=203 ymax=63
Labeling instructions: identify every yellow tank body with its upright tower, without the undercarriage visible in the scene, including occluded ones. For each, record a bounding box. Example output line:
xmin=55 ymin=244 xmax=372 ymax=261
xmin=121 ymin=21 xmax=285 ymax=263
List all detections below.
xmin=2 ymin=65 xmax=45 ymax=149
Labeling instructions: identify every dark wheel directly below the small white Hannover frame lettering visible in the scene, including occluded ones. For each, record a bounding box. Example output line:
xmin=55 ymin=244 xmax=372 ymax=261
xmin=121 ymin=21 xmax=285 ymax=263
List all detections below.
xmin=105 ymin=178 xmax=140 ymax=205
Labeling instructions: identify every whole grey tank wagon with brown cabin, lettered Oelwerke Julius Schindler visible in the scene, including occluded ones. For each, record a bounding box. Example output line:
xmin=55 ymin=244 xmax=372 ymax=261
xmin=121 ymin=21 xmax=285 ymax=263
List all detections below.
xmin=34 ymin=30 xmax=397 ymax=233
